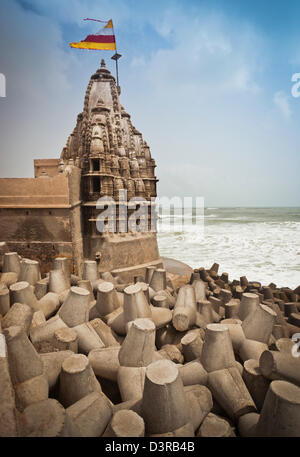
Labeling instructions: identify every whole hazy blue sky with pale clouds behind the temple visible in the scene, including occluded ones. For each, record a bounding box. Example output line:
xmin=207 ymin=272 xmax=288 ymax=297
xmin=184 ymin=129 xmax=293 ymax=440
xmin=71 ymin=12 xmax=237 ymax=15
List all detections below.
xmin=0 ymin=0 xmax=300 ymax=206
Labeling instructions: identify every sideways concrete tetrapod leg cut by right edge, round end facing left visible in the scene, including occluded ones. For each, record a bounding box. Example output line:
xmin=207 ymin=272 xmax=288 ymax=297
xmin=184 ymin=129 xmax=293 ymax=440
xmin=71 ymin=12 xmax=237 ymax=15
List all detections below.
xmin=259 ymin=350 xmax=300 ymax=386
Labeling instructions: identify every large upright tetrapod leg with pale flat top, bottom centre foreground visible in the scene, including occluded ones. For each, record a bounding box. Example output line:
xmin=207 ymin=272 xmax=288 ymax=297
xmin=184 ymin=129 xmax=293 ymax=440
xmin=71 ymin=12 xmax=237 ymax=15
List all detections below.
xmin=142 ymin=360 xmax=191 ymax=435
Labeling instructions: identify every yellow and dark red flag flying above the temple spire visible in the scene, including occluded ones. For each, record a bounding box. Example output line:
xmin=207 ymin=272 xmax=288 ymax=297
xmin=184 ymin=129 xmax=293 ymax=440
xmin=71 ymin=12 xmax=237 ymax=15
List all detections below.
xmin=70 ymin=18 xmax=117 ymax=51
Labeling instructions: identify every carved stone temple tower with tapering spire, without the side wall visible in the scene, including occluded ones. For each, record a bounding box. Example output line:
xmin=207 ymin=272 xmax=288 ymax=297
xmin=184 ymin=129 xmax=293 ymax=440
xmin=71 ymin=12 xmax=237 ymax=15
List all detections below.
xmin=60 ymin=60 xmax=161 ymax=278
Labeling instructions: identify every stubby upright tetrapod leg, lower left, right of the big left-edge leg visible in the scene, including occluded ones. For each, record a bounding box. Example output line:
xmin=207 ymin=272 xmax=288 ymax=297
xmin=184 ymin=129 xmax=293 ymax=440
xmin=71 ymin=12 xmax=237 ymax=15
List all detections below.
xmin=59 ymin=354 xmax=102 ymax=407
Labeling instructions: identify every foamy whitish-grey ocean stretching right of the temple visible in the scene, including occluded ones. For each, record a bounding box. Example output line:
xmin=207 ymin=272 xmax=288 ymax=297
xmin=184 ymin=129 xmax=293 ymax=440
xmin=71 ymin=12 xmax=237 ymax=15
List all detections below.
xmin=158 ymin=208 xmax=300 ymax=289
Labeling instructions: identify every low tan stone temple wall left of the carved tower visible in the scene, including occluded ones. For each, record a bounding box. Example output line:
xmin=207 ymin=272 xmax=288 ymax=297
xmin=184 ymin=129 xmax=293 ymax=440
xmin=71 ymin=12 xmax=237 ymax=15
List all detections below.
xmin=0 ymin=169 xmax=83 ymax=273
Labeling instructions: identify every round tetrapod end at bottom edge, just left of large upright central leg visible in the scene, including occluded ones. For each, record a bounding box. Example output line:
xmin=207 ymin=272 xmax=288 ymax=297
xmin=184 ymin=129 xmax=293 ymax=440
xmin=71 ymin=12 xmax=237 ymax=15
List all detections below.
xmin=102 ymin=409 xmax=145 ymax=438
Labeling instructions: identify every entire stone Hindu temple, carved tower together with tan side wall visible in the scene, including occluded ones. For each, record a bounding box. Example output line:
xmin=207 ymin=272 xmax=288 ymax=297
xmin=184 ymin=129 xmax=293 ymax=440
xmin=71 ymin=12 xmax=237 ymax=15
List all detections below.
xmin=0 ymin=60 xmax=162 ymax=279
